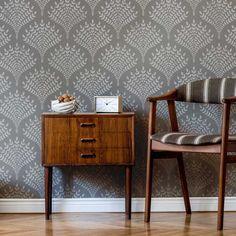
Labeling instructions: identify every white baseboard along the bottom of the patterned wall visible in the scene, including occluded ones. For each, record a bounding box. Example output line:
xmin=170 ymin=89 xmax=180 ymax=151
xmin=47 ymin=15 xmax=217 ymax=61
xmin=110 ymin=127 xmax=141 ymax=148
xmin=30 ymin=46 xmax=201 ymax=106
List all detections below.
xmin=0 ymin=197 xmax=236 ymax=213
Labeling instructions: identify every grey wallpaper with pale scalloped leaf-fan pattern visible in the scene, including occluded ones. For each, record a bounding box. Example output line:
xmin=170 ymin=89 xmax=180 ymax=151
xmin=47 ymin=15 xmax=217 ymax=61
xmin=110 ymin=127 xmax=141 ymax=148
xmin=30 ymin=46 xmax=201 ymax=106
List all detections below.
xmin=0 ymin=0 xmax=236 ymax=198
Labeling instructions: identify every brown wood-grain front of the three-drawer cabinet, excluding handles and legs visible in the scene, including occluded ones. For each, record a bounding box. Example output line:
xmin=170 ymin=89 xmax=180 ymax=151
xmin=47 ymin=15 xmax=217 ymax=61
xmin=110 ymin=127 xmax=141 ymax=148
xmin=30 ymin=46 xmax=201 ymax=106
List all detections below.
xmin=43 ymin=115 xmax=134 ymax=165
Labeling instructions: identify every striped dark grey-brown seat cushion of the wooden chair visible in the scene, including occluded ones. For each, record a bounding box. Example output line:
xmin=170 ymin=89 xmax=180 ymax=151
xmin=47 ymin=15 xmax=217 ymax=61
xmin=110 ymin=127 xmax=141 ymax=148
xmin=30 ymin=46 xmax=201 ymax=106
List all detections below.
xmin=152 ymin=132 xmax=236 ymax=145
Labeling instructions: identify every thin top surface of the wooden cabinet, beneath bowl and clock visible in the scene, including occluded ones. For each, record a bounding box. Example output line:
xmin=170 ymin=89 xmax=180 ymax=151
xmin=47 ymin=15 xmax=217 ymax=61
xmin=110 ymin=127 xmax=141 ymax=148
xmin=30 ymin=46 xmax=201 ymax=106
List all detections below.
xmin=42 ymin=112 xmax=135 ymax=117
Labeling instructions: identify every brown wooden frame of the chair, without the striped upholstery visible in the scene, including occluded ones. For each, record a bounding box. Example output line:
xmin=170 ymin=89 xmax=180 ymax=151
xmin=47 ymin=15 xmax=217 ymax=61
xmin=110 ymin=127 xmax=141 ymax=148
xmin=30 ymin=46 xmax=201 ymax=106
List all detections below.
xmin=145 ymin=89 xmax=236 ymax=230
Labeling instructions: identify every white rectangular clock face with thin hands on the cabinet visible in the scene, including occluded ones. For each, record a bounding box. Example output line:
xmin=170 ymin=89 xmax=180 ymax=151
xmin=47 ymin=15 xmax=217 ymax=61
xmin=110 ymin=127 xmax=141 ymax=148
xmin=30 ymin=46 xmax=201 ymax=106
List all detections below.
xmin=95 ymin=97 xmax=118 ymax=112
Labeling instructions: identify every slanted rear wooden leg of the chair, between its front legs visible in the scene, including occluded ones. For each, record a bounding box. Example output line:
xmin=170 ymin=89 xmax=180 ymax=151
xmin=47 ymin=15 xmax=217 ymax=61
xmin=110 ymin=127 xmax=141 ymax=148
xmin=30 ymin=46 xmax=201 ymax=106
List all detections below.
xmin=177 ymin=154 xmax=191 ymax=214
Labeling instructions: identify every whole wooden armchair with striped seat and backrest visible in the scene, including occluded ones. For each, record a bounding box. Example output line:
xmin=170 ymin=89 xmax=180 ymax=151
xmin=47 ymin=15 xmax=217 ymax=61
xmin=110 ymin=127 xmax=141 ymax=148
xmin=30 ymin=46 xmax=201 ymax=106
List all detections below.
xmin=145 ymin=78 xmax=236 ymax=230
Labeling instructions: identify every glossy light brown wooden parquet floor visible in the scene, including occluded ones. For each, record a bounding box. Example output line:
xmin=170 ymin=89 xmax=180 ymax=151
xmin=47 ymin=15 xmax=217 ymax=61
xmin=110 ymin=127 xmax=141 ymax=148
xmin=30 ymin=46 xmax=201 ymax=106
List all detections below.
xmin=0 ymin=213 xmax=236 ymax=236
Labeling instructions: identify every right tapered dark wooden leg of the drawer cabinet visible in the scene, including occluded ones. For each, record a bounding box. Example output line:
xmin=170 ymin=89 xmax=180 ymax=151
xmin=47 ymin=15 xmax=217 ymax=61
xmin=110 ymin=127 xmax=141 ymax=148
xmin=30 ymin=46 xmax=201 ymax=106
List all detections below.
xmin=125 ymin=166 xmax=132 ymax=219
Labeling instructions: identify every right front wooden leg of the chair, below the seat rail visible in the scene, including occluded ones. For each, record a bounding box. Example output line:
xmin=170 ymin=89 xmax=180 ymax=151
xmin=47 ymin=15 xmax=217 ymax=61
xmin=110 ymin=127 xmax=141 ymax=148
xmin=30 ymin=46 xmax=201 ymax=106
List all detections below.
xmin=217 ymin=156 xmax=226 ymax=230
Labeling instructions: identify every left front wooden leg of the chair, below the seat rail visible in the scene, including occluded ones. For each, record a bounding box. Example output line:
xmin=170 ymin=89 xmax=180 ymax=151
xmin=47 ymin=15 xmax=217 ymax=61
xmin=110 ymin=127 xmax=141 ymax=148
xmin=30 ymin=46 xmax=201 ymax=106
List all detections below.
xmin=144 ymin=150 xmax=153 ymax=222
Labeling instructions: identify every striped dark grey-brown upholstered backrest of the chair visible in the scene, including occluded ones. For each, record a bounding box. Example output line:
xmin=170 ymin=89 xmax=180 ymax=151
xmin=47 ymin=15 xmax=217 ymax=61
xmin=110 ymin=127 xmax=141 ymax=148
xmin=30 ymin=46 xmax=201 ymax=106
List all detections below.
xmin=176 ymin=78 xmax=236 ymax=103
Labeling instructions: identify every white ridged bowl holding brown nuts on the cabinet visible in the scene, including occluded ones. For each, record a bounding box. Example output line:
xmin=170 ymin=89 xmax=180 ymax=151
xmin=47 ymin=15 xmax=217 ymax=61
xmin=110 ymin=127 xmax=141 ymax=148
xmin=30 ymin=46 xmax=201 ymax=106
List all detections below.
xmin=51 ymin=100 xmax=78 ymax=113
